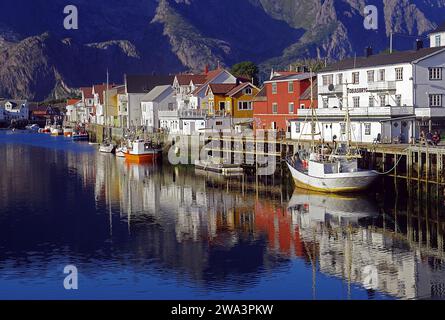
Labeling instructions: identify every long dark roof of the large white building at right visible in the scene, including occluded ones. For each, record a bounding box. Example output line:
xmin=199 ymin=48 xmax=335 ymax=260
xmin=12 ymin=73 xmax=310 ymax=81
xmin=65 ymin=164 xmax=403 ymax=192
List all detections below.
xmin=320 ymin=47 xmax=445 ymax=73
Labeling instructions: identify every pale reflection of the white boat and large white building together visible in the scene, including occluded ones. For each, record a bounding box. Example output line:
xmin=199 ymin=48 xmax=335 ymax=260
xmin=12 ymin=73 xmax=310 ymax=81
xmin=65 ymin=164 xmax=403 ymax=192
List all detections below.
xmin=289 ymin=194 xmax=445 ymax=299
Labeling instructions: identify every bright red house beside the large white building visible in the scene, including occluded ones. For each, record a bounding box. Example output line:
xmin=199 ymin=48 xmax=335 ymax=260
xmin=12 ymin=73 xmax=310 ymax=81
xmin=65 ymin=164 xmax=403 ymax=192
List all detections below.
xmin=253 ymin=72 xmax=316 ymax=132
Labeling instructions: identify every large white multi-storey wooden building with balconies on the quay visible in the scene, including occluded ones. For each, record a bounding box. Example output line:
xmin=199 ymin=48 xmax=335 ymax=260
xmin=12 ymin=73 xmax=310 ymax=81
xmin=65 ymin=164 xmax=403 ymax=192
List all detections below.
xmin=291 ymin=42 xmax=445 ymax=143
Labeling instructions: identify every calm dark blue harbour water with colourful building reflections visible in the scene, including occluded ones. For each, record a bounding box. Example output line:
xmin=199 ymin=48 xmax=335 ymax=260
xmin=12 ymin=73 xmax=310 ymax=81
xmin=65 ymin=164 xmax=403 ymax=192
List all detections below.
xmin=0 ymin=131 xmax=445 ymax=300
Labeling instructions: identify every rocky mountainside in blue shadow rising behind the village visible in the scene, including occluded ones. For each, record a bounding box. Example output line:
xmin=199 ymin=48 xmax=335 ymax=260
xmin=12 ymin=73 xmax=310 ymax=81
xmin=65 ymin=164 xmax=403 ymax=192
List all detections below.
xmin=0 ymin=0 xmax=445 ymax=100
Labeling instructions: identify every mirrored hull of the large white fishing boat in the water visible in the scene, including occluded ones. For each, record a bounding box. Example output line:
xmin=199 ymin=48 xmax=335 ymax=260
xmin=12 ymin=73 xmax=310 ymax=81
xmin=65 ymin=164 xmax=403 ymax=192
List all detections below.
xmin=288 ymin=189 xmax=378 ymax=224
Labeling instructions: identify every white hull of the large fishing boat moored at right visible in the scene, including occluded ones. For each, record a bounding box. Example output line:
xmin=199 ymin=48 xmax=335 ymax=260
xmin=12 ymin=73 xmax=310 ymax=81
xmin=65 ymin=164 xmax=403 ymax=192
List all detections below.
xmin=287 ymin=163 xmax=378 ymax=193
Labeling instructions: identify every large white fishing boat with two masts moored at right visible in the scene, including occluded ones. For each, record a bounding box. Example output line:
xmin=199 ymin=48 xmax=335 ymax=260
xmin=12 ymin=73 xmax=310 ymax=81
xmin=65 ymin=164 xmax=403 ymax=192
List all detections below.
xmin=286 ymin=72 xmax=379 ymax=193
